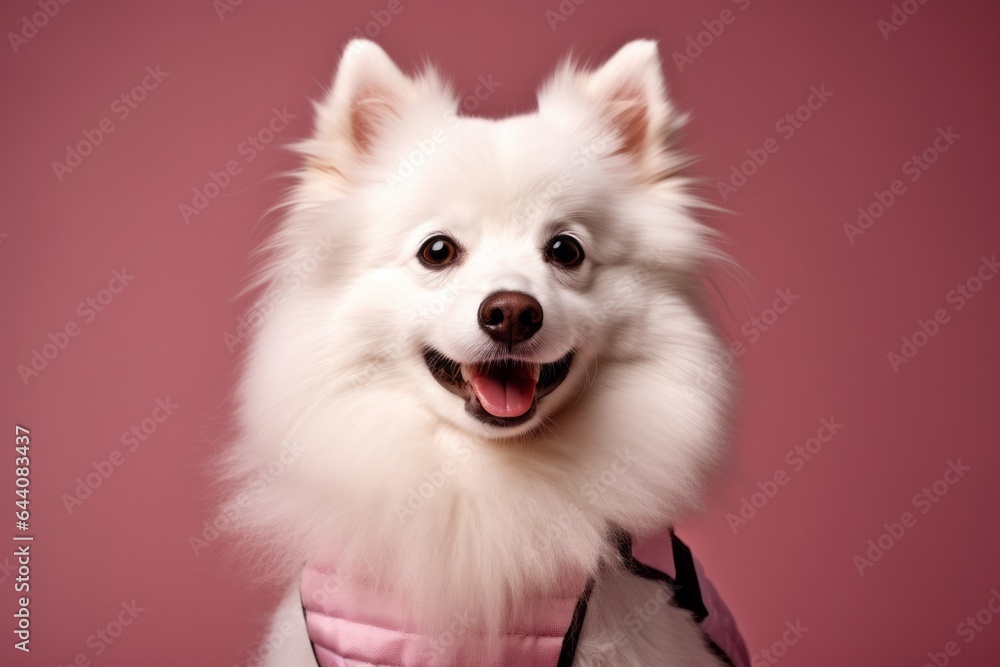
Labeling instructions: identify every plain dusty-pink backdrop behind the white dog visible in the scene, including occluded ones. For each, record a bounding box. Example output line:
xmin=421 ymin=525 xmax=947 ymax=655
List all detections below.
xmin=0 ymin=0 xmax=1000 ymax=667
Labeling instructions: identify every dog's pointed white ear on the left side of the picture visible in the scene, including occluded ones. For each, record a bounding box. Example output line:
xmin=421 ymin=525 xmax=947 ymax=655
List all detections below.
xmin=303 ymin=39 xmax=450 ymax=176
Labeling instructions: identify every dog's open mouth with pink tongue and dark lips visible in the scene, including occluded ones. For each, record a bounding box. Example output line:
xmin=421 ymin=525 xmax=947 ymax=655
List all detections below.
xmin=424 ymin=348 xmax=573 ymax=426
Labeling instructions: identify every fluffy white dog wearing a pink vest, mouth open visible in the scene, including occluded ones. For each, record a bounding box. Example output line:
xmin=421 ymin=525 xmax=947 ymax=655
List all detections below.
xmin=224 ymin=40 xmax=745 ymax=667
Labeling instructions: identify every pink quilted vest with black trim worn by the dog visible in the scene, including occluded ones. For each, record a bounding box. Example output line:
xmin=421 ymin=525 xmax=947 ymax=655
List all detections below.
xmin=300 ymin=531 xmax=750 ymax=667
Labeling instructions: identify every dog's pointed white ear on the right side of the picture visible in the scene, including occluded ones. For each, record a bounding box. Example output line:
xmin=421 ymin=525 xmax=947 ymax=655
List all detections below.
xmin=539 ymin=39 xmax=685 ymax=178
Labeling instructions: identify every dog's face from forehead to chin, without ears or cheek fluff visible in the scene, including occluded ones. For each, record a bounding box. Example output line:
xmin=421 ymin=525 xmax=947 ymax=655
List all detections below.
xmin=371 ymin=117 xmax=629 ymax=437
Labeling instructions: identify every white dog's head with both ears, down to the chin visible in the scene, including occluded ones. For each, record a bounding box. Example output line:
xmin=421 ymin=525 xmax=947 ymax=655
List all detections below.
xmin=262 ymin=41 xmax=724 ymax=438
